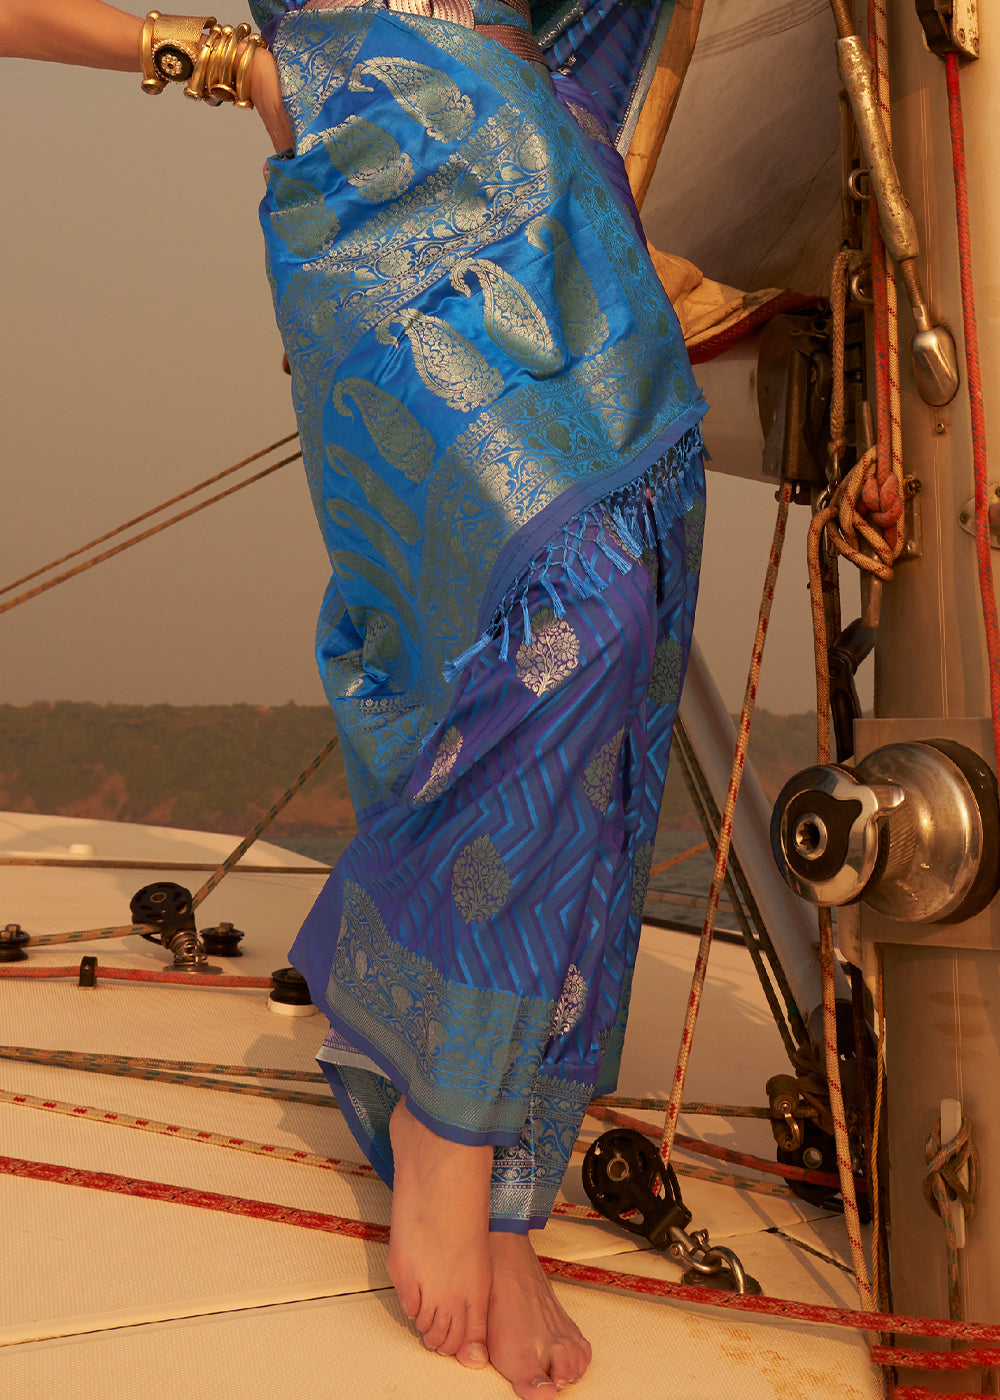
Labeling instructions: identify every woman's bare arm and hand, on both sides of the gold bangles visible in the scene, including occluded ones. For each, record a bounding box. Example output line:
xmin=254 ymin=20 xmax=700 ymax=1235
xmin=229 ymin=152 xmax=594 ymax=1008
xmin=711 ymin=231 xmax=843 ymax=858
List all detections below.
xmin=0 ymin=0 xmax=294 ymax=151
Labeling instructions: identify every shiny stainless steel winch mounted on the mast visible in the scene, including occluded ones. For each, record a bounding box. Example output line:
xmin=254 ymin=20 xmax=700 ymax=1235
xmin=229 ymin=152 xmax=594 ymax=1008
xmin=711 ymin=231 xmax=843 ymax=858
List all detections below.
xmin=770 ymin=739 xmax=1000 ymax=924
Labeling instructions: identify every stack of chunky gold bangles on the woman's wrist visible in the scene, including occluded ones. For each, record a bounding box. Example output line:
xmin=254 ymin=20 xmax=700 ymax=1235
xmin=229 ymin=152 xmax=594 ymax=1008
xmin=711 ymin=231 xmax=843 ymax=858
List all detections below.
xmin=140 ymin=10 xmax=265 ymax=108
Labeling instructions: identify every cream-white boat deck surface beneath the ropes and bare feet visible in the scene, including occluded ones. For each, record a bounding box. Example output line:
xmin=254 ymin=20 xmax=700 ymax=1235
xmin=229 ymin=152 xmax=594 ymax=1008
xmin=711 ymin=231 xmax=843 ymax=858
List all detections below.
xmin=0 ymin=816 xmax=878 ymax=1400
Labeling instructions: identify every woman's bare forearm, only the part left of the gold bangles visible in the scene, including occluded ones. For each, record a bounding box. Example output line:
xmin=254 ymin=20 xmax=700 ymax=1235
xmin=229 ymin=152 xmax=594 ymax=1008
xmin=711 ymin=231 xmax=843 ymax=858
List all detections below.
xmin=0 ymin=0 xmax=143 ymax=73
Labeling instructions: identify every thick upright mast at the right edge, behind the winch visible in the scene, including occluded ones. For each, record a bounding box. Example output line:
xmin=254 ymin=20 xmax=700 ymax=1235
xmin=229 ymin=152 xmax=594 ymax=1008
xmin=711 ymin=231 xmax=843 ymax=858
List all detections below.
xmin=856 ymin=4 xmax=1000 ymax=1355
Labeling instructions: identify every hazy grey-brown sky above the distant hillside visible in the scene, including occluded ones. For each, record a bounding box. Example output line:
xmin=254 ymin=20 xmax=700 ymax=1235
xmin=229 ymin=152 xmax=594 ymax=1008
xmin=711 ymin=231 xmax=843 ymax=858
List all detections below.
xmin=0 ymin=3 xmax=857 ymax=711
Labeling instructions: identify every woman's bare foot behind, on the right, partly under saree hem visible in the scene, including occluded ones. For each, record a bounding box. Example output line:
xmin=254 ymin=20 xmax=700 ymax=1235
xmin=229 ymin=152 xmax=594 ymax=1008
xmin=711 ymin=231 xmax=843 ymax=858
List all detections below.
xmin=487 ymin=1231 xmax=591 ymax=1400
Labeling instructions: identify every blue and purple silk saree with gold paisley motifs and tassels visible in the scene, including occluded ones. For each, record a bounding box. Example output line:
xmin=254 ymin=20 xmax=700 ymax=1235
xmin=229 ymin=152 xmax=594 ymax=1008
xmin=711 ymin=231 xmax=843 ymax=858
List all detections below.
xmin=252 ymin=0 xmax=706 ymax=1229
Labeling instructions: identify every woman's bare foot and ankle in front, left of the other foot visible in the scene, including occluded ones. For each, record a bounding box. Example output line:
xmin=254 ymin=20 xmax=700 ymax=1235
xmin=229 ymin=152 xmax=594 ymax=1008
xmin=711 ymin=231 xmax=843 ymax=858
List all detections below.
xmin=389 ymin=1099 xmax=493 ymax=1369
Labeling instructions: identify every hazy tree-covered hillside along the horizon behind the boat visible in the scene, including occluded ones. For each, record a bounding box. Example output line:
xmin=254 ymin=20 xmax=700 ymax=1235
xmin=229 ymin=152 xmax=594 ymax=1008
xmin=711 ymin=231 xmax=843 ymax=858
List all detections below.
xmin=0 ymin=701 xmax=815 ymax=839
